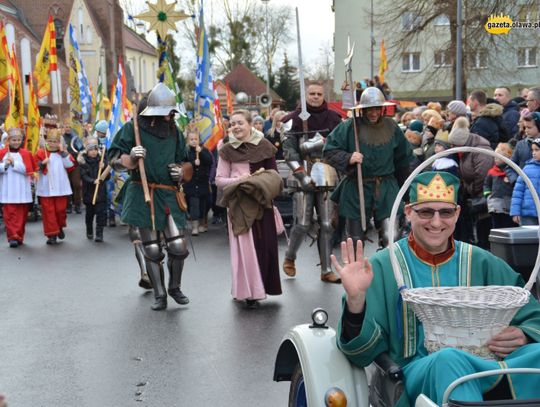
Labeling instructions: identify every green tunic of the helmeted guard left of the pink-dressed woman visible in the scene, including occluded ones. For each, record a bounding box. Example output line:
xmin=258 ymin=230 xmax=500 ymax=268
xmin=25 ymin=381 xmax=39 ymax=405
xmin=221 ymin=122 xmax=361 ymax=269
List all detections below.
xmin=109 ymin=122 xmax=186 ymax=231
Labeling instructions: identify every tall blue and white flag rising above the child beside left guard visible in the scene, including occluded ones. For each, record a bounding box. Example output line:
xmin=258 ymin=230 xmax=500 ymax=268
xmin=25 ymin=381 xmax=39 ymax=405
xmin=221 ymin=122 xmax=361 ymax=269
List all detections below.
xmin=195 ymin=0 xmax=219 ymax=150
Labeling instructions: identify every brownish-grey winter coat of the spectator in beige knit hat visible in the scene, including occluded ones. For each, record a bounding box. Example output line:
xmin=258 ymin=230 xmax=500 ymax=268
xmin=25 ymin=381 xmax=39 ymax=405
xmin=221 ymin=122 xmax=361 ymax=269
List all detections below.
xmin=459 ymin=133 xmax=493 ymax=198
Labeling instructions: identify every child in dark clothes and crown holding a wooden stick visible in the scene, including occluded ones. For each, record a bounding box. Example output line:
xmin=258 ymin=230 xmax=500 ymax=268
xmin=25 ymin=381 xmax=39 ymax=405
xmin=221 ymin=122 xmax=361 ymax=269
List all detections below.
xmin=80 ymin=137 xmax=109 ymax=242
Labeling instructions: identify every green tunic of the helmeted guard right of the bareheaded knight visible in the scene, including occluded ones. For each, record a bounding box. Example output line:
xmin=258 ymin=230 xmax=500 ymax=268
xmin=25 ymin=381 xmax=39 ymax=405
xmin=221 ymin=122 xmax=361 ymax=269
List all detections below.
xmin=324 ymin=117 xmax=413 ymax=220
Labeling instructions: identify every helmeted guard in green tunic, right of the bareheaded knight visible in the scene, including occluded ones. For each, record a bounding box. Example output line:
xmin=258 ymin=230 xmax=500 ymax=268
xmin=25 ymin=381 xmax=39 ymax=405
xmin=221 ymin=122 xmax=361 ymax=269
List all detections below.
xmin=324 ymin=87 xmax=413 ymax=247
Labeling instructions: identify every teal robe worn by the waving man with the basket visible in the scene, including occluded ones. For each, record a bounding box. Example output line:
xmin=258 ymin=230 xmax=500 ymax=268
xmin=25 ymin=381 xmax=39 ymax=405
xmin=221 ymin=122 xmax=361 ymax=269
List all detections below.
xmin=337 ymin=238 xmax=540 ymax=406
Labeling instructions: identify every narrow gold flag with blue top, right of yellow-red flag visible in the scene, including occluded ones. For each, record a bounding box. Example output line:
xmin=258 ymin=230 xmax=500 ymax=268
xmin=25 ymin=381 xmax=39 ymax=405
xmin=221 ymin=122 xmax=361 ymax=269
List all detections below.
xmin=68 ymin=24 xmax=83 ymax=138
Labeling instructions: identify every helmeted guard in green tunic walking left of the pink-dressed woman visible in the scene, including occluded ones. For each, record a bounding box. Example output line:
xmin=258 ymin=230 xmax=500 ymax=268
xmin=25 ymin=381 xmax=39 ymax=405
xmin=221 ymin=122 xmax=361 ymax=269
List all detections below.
xmin=108 ymin=83 xmax=190 ymax=311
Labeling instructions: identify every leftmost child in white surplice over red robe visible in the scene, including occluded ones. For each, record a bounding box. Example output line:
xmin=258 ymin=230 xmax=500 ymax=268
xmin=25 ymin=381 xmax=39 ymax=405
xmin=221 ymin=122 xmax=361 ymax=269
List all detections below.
xmin=0 ymin=128 xmax=37 ymax=248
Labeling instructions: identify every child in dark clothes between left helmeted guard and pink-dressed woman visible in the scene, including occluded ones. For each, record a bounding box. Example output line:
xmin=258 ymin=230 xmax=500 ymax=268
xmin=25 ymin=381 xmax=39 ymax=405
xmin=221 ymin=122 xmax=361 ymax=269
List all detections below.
xmin=183 ymin=126 xmax=213 ymax=236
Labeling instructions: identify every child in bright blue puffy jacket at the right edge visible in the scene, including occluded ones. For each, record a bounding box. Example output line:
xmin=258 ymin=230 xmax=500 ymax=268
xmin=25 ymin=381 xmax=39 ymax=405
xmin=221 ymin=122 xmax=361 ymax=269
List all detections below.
xmin=510 ymin=138 xmax=540 ymax=225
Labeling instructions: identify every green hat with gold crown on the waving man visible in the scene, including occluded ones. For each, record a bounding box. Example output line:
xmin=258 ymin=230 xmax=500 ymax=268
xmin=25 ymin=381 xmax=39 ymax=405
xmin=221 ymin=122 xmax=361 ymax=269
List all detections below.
xmin=409 ymin=171 xmax=459 ymax=205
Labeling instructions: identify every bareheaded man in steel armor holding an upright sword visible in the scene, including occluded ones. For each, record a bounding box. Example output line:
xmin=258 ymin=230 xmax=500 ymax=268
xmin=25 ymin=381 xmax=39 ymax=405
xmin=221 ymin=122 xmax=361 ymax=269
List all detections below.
xmin=282 ymin=83 xmax=341 ymax=283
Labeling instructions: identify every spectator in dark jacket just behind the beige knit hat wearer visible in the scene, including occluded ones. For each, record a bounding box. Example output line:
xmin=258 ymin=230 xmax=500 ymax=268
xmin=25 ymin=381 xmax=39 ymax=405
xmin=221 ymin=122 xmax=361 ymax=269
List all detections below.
xmin=469 ymin=90 xmax=508 ymax=149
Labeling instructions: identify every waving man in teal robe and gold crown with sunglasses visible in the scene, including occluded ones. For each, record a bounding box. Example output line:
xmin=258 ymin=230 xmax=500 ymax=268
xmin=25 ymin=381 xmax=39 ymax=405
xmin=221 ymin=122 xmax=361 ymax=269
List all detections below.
xmin=332 ymin=172 xmax=540 ymax=406
